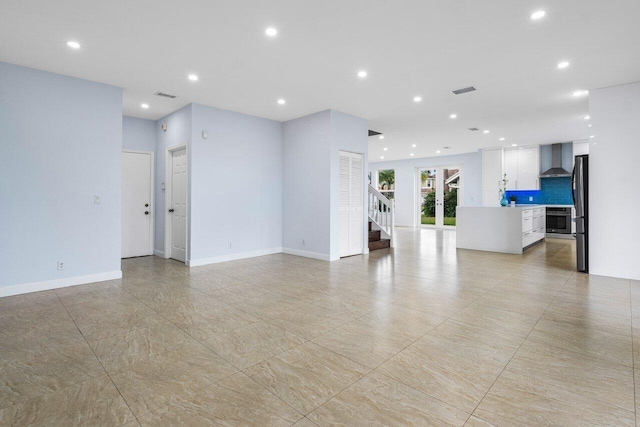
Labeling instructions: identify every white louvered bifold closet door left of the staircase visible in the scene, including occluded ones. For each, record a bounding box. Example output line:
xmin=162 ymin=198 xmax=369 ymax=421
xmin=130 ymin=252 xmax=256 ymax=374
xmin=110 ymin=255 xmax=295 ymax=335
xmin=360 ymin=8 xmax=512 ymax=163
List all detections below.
xmin=339 ymin=151 xmax=364 ymax=257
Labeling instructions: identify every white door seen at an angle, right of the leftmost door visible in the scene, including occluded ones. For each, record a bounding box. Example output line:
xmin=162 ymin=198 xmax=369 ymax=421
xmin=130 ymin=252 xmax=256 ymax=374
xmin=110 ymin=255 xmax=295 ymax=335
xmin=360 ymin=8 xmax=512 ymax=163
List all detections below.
xmin=169 ymin=148 xmax=187 ymax=262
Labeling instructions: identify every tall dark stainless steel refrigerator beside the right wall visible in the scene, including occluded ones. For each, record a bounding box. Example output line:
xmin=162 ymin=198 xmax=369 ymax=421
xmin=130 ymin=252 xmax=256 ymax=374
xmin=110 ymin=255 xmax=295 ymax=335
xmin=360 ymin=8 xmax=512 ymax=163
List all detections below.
xmin=571 ymin=154 xmax=589 ymax=273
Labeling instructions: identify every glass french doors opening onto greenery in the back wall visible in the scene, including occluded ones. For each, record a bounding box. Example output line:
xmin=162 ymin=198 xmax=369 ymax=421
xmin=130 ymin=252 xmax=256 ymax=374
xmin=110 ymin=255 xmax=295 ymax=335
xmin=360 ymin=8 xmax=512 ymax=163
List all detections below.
xmin=416 ymin=166 xmax=462 ymax=228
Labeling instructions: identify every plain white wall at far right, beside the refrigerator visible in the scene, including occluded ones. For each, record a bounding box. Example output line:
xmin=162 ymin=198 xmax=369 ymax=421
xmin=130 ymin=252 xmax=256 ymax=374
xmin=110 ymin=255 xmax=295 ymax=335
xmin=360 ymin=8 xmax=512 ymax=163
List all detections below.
xmin=589 ymin=82 xmax=640 ymax=280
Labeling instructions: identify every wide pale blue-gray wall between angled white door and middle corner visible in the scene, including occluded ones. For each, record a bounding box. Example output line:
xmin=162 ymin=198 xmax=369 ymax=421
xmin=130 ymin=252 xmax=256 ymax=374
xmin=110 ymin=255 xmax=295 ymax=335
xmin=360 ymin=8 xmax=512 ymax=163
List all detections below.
xmin=190 ymin=104 xmax=282 ymax=264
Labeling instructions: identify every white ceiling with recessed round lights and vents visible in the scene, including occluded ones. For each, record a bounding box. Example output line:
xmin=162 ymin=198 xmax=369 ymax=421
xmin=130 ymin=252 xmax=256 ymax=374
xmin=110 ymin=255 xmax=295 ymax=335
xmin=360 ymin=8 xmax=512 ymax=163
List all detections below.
xmin=0 ymin=0 xmax=640 ymax=161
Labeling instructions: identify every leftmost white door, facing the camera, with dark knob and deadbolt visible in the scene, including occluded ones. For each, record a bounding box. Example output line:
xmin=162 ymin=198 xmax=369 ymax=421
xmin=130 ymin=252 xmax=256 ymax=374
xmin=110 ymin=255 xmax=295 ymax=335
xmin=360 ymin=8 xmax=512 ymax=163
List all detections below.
xmin=122 ymin=151 xmax=153 ymax=258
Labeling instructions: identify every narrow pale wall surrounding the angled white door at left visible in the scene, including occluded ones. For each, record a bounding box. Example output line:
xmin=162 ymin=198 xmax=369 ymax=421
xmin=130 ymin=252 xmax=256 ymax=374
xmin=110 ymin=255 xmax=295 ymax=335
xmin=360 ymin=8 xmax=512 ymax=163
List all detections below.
xmin=155 ymin=104 xmax=191 ymax=257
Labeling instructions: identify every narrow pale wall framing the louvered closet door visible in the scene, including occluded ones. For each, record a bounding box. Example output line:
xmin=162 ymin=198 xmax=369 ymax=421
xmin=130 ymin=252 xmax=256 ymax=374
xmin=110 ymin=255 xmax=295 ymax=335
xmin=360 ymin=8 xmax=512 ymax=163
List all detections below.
xmin=329 ymin=110 xmax=369 ymax=260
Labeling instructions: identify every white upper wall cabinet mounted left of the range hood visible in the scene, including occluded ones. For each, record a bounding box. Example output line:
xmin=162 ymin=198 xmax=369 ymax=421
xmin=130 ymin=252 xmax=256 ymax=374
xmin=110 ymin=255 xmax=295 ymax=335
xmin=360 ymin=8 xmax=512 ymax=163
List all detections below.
xmin=504 ymin=147 xmax=540 ymax=190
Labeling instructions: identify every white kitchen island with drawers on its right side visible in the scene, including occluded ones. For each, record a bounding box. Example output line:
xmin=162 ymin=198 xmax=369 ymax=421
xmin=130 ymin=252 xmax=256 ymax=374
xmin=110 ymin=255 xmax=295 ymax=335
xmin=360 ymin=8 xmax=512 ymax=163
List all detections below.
xmin=456 ymin=205 xmax=546 ymax=254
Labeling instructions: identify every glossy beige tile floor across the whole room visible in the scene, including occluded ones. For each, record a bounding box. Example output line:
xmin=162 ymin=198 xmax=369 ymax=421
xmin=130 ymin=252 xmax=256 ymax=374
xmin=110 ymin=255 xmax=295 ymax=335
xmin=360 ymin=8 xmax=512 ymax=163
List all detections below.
xmin=0 ymin=229 xmax=640 ymax=426
